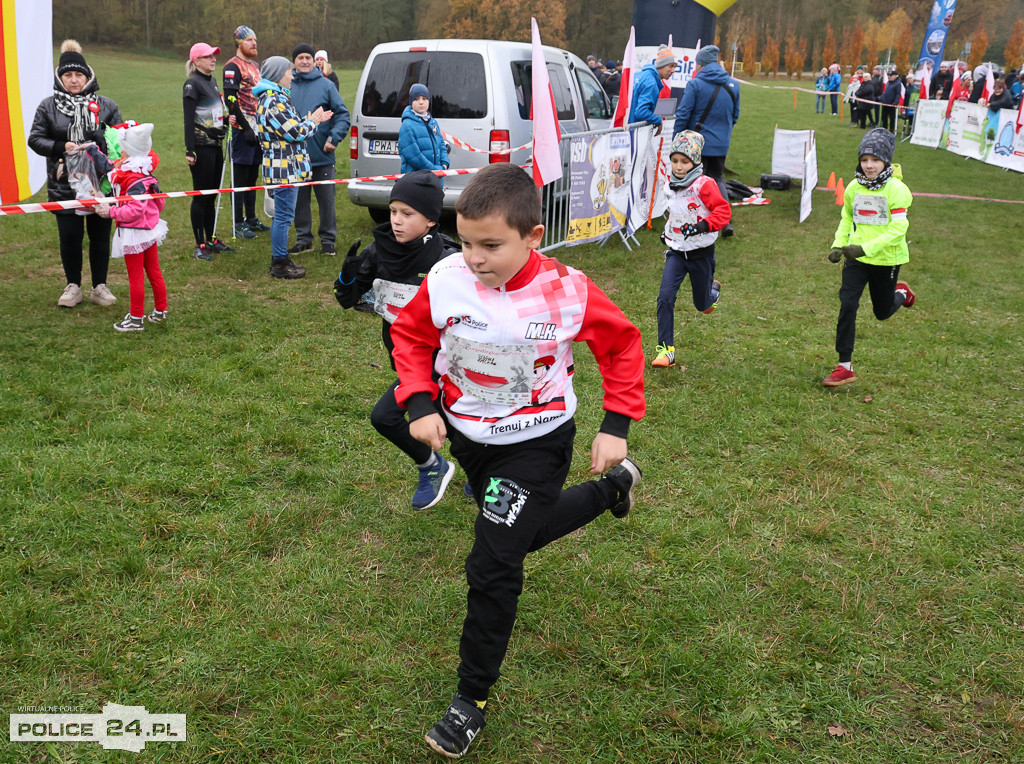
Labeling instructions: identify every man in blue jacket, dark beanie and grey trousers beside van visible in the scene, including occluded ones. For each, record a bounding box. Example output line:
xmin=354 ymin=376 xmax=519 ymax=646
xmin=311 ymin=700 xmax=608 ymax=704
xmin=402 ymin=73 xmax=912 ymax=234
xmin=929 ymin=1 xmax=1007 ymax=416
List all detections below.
xmin=288 ymin=42 xmax=350 ymax=255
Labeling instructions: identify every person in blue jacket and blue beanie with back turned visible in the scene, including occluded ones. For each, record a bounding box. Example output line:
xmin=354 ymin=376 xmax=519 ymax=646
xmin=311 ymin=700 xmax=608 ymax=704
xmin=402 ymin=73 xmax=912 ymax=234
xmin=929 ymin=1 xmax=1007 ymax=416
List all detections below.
xmin=672 ymin=45 xmax=739 ymax=237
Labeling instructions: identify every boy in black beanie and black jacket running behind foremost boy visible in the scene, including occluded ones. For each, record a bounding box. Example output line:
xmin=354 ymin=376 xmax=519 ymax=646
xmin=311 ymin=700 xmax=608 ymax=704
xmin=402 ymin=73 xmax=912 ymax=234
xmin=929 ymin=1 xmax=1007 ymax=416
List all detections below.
xmin=334 ymin=170 xmax=459 ymax=509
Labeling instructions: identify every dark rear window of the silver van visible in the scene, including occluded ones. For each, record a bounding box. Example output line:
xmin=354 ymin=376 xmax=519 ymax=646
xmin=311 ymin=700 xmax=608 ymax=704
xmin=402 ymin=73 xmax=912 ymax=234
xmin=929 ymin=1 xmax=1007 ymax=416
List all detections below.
xmin=360 ymin=51 xmax=487 ymax=119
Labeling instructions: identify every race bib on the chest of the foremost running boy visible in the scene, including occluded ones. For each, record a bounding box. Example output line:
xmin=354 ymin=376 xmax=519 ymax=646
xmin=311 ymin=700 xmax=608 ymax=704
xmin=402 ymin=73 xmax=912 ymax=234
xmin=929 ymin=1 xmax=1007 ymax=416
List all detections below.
xmin=446 ymin=334 xmax=537 ymax=409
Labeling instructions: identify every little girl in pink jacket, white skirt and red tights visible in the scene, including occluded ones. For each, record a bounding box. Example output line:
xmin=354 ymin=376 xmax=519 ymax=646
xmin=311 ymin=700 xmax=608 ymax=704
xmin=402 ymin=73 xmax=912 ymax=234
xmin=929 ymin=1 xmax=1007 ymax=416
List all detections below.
xmin=96 ymin=123 xmax=167 ymax=332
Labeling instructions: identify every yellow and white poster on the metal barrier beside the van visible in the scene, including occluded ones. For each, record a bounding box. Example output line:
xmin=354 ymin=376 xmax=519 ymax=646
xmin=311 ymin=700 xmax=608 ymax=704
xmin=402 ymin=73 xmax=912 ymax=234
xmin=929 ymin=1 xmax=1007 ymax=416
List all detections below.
xmin=565 ymin=132 xmax=633 ymax=247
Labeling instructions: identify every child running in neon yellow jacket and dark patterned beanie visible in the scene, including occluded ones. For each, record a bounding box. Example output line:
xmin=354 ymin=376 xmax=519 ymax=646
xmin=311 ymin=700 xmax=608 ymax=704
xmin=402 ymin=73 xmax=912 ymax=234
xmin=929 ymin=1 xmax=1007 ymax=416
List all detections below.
xmin=822 ymin=127 xmax=916 ymax=387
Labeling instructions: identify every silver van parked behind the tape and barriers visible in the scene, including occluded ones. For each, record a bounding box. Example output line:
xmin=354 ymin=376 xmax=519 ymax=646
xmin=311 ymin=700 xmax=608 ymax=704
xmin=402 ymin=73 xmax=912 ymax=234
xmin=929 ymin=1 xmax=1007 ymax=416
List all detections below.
xmin=348 ymin=40 xmax=613 ymax=222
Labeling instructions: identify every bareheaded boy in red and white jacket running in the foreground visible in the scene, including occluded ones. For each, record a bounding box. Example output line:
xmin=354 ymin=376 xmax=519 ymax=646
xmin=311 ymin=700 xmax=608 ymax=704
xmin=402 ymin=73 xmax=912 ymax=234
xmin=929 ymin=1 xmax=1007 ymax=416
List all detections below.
xmin=391 ymin=163 xmax=646 ymax=758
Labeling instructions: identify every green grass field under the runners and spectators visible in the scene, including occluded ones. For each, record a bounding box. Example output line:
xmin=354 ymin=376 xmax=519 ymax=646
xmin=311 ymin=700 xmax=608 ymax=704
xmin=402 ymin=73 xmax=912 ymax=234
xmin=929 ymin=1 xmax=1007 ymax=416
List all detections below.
xmin=0 ymin=50 xmax=1024 ymax=764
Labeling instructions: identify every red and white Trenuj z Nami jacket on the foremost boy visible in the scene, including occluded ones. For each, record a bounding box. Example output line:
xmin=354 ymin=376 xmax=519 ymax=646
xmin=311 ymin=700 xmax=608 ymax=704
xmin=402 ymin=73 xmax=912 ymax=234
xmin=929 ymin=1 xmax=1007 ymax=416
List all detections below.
xmin=391 ymin=251 xmax=646 ymax=444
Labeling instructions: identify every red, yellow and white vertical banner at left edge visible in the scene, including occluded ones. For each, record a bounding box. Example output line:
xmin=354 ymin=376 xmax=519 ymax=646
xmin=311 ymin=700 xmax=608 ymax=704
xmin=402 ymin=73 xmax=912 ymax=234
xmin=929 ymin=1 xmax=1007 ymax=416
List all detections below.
xmin=0 ymin=0 xmax=53 ymax=204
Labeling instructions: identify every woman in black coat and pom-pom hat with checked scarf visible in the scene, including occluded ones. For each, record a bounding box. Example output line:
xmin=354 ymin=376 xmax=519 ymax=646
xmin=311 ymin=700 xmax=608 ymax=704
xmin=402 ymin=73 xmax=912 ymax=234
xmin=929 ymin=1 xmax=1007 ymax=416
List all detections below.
xmin=29 ymin=40 xmax=122 ymax=307
